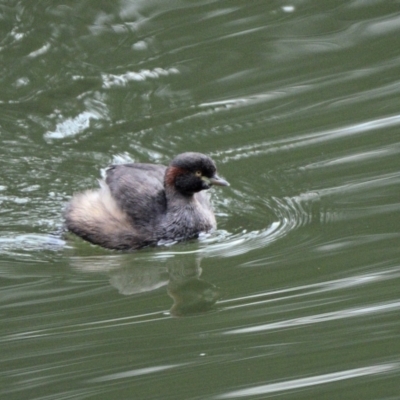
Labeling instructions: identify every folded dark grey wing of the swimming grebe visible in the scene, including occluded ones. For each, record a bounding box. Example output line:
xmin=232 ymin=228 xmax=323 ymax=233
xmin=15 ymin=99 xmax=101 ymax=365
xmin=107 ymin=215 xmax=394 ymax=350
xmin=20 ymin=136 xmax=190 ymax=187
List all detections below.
xmin=106 ymin=164 xmax=166 ymax=228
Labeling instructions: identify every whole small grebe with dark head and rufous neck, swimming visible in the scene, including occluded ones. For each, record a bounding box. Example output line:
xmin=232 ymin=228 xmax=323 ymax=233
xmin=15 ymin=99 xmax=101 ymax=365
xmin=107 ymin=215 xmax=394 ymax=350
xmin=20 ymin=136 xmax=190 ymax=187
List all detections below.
xmin=65 ymin=153 xmax=228 ymax=249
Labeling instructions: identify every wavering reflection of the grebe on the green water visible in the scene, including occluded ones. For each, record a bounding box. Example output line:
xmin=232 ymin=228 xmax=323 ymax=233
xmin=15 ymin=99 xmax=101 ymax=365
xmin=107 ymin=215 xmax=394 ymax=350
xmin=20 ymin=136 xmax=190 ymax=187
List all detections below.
xmin=70 ymin=253 xmax=221 ymax=317
